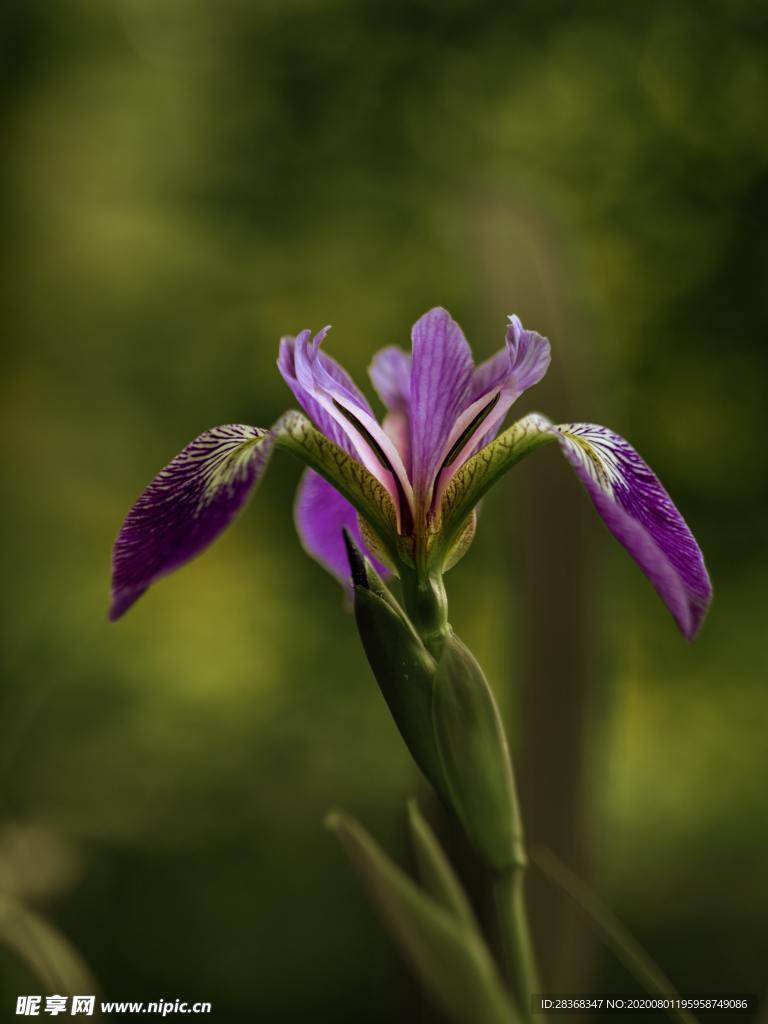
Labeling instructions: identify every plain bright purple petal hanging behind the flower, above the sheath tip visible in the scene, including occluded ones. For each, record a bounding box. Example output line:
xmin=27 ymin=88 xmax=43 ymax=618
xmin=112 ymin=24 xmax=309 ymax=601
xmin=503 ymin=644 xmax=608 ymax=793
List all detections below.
xmin=295 ymin=469 xmax=389 ymax=583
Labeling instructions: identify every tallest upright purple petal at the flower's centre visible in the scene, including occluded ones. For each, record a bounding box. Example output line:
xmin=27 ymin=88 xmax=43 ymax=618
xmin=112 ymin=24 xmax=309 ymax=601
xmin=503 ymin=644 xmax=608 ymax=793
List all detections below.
xmin=411 ymin=307 xmax=473 ymax=500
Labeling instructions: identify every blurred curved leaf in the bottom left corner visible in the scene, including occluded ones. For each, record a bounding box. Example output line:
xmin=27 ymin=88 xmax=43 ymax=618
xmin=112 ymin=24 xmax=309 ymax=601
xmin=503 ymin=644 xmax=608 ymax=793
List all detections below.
xmin=0 ymin=895 xmax=98 ymax=995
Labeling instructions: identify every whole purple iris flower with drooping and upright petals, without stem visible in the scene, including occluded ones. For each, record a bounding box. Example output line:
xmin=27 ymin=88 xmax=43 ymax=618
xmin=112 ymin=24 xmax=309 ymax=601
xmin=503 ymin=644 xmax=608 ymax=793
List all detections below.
xmin=111 ymin=308 xmax=712 ymax=638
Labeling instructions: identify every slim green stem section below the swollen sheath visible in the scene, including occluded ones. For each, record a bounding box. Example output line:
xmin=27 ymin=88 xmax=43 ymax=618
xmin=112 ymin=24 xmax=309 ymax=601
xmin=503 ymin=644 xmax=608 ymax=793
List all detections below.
xmin=493 ymin=863 xmax=542 ymax=1020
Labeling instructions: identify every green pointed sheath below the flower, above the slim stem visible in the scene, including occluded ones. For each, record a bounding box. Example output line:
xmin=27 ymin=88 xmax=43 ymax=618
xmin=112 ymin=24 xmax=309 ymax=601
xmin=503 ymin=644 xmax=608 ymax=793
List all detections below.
xmin=346 ymin=535 xmax=525 ymax=870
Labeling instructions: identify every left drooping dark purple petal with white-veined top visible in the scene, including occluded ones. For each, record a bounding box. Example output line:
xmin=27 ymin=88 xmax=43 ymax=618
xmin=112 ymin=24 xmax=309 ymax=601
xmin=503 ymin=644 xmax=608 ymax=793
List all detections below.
xmin=110 ymin=424 xmax=273 ymax=620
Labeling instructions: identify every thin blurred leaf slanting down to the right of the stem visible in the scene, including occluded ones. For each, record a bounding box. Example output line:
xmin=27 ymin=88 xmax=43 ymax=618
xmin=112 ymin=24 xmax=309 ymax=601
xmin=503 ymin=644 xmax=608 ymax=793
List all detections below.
xmin=532 ymin=849 xmax=696 ymax=1024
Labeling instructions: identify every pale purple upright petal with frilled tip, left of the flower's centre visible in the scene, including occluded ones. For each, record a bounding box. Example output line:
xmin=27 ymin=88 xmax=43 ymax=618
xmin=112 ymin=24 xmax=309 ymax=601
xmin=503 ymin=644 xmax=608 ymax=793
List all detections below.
xmin=278 ymin=328 xmax=411 ymax=516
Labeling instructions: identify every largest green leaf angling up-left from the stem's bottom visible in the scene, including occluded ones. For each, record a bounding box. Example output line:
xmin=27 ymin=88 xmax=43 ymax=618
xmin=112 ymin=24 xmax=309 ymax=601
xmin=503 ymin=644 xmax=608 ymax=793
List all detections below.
xmin=327 ymin=813 xmax=519 ymax=1024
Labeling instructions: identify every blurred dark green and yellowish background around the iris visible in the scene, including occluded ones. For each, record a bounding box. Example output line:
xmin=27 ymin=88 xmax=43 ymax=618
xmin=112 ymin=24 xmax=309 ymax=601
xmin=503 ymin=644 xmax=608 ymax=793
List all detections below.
xmin=0 ymin=0 xmax=768 ymax=1022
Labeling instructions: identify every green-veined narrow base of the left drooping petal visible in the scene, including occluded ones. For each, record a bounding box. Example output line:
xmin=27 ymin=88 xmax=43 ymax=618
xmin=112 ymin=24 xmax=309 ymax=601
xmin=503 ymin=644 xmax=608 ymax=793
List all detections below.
xmin=272 ymin=411 xmax=397 ymax=559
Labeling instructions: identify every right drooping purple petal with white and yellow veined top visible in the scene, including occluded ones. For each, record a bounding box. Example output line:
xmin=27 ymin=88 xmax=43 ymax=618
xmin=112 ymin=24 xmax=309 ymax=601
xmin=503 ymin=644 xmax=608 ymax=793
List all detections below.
xmin=552 ymin=423 xmax=712 ymax=639
